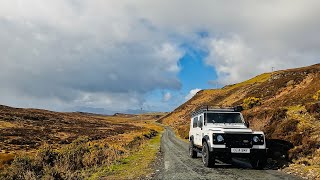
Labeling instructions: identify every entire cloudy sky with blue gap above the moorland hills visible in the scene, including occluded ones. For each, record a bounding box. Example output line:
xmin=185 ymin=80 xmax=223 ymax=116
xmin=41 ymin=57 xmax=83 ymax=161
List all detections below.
xmin=0 ymin=0 xmax=320 ymax=113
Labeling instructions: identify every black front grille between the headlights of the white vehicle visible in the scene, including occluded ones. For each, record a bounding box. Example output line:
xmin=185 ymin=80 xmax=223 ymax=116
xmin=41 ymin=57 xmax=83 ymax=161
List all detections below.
xmin=225 ymin=134 xmax=252 ymax=148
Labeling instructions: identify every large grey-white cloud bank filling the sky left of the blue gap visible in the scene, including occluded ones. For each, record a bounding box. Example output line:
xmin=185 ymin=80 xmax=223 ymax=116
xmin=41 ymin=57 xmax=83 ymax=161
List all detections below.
xmin=0 ymin=0 xmax=183 ymax=111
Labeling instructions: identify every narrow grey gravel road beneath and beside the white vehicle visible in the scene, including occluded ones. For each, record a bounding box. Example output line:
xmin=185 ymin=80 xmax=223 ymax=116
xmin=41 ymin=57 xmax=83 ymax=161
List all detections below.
xmin=153 ymin=128 xmax=300 ymax=180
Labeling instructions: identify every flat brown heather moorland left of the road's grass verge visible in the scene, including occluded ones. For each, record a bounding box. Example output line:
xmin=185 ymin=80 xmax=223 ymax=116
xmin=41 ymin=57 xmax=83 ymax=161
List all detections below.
xmin=0 ymin=106 xmax=163 ymax=179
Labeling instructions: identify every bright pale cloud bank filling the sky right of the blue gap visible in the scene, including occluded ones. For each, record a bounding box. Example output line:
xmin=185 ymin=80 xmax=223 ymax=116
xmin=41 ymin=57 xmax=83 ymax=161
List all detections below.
xmin=133 ymin=0 xmax=320 ymax=84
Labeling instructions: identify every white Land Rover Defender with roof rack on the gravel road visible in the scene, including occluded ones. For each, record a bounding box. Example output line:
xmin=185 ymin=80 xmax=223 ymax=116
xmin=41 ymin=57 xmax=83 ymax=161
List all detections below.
xmin=189 ymin=106 xmax=267 ymax=169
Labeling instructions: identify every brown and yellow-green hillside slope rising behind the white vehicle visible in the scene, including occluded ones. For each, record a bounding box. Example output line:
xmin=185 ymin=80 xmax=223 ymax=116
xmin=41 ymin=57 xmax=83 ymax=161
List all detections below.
xmin=161 ymin=64 xmax=320 ymax=178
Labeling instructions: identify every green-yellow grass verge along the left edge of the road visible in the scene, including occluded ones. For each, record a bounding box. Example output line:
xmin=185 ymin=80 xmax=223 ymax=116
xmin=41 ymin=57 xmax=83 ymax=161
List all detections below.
xmin=89 ymin=132 xmax=162 ymax=179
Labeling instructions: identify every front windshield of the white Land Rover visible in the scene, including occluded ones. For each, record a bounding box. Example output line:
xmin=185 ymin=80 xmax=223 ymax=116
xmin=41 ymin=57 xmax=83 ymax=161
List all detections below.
xmin=204 ymin=113 xmax=243 ymax=123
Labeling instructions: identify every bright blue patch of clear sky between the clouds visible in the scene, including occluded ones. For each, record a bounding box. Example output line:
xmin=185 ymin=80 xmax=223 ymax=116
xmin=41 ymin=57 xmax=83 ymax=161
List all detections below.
xmin=144 ymin=44 xmax=217 ymax=111
